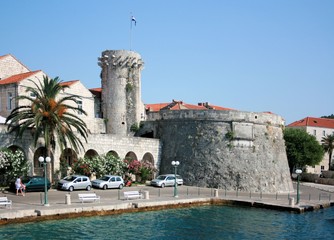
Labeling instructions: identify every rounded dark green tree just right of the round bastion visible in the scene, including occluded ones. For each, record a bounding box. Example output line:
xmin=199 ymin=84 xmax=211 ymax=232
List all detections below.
xmin=284 ymin=128 xmax=324 ymax=173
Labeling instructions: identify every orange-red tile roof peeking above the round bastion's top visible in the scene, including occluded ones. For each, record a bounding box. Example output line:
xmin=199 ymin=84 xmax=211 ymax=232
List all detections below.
xmin=145 ymin=100 xmax=232 ymax=112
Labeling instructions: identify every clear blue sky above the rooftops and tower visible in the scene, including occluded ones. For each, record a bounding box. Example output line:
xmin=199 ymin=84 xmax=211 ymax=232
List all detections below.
xmin=0 ymin=0 xmax=334 ymax=123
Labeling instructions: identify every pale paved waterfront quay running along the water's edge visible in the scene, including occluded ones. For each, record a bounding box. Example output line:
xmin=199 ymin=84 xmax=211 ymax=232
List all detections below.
xmin=0 ymin=183 xmax=334 ymax=225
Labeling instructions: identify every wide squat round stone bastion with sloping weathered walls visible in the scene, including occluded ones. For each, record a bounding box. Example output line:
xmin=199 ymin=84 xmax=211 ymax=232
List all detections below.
xmin=143 ymin=110 xmax=293 ymax=193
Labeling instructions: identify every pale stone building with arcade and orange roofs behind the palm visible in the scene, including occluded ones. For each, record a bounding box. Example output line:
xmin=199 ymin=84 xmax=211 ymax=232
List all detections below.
xmin=0 ymin=54 xmax=160 ymax=179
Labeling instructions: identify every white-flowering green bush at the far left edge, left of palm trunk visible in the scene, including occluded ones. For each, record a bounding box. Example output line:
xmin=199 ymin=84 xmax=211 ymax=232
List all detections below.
xmin=0 ymin=149 xmax=29 ymax=185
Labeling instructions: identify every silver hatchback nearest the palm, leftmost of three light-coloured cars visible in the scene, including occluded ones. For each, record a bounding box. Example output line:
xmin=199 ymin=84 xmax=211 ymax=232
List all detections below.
xmin=58 ymin=175 xmax=92 ymax=192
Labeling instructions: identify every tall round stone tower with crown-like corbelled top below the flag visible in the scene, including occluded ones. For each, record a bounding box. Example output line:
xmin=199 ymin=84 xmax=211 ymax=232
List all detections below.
xmin=98 ymin=50 xmax=145 ymax=136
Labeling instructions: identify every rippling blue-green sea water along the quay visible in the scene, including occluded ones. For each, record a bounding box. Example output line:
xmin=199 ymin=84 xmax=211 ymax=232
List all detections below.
xmin=0 ymin=206 xmax=334 ymax=240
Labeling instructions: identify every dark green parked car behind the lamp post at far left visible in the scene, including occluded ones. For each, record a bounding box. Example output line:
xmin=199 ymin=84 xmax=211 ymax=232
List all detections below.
xmin=10 ymin=176 xmax=51 ymax=192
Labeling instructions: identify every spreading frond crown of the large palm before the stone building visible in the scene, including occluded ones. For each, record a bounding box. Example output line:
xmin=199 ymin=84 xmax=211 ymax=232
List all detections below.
xmin=6 ymin=76 xmax=88 ymax=169
